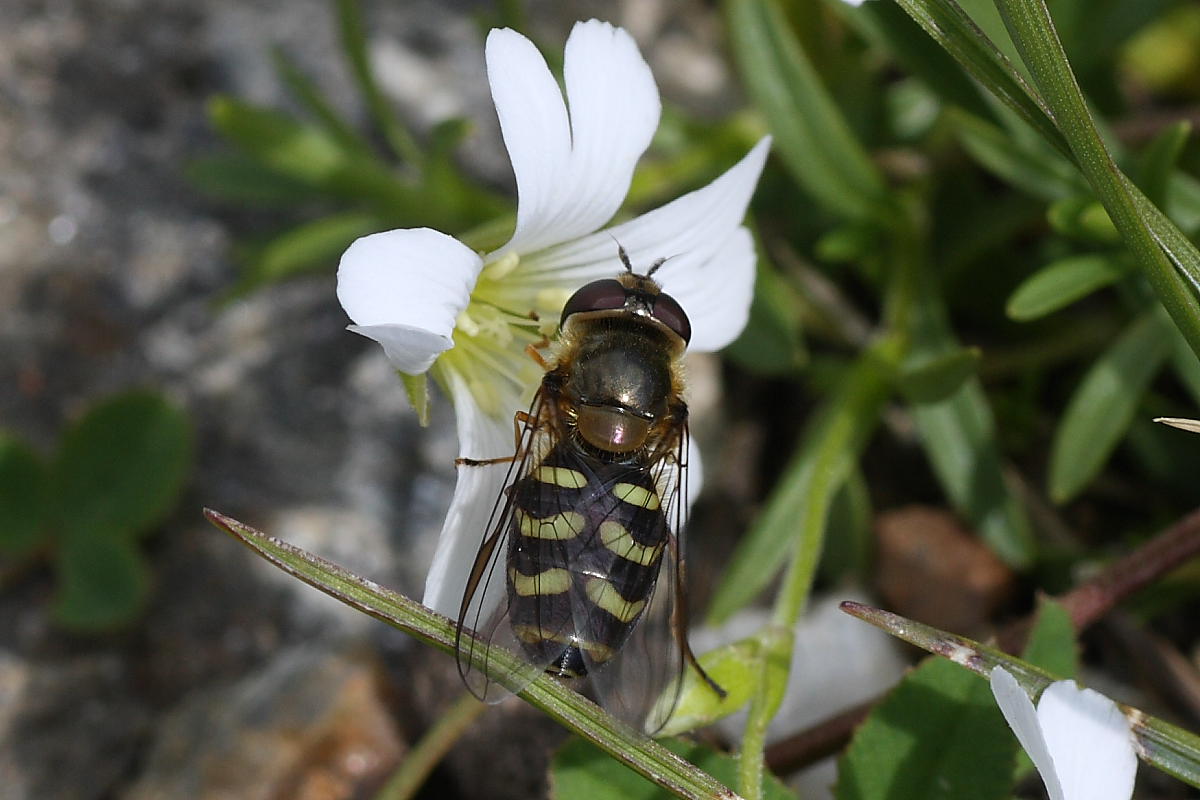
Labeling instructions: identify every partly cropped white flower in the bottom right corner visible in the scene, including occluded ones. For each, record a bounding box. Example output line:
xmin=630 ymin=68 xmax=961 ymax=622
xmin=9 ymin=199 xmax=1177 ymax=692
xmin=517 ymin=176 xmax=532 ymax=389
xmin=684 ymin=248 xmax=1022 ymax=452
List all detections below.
xmin=991 ymin=667 xmax=1138 ymax=800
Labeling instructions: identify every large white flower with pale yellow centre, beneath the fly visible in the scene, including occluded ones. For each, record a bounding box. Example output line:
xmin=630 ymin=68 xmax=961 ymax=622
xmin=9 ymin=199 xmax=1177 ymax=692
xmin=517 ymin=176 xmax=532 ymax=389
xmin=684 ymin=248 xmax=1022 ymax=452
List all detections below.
xmin=337 ymin=20 xmax=769 ymax=615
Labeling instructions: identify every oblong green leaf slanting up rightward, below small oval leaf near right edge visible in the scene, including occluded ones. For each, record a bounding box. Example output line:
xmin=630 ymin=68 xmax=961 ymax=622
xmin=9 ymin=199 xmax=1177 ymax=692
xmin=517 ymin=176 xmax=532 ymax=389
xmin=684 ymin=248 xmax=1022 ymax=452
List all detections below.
xmin=1049 ymin=311 xmax=1171 ymax=503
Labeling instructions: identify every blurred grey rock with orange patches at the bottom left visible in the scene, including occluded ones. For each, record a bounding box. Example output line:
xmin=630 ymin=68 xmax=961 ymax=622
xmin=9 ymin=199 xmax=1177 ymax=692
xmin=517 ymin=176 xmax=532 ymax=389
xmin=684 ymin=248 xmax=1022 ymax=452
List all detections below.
xmin=122 ymin=645 xmax=406 ymax=800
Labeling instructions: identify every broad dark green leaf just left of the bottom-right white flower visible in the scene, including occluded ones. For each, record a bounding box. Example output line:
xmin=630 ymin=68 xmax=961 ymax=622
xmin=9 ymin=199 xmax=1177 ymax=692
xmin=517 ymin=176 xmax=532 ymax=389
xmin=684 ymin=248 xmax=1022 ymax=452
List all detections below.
xmin=835 ymin=658 xmax=1016 ymax=800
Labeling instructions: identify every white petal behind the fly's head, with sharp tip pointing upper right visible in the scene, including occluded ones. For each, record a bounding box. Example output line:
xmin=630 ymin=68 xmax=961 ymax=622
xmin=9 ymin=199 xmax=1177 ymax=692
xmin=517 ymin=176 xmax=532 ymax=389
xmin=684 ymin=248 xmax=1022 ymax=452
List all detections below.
xmin=522 ymin=137 xmax=770 ymax=351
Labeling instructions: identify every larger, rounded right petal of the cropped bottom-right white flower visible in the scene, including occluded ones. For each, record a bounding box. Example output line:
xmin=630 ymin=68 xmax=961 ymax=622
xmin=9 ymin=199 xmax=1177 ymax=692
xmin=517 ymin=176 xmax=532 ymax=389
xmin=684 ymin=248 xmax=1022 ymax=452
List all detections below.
xmin=1038 ymin=680 xmax=1138 ymax=800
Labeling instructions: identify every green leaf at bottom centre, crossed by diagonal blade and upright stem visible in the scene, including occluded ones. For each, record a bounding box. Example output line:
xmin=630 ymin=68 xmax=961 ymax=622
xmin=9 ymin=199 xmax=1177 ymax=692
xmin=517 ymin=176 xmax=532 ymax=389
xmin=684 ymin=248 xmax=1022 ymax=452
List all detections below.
xmin=550 ymin=739 xmax=796 ymax=800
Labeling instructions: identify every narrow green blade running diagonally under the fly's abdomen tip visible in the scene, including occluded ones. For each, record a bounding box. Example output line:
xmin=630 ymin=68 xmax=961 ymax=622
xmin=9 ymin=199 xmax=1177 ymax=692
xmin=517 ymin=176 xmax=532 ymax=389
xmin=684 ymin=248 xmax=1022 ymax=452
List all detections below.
xmin=204 ymin=510 xmax=737 ymax=800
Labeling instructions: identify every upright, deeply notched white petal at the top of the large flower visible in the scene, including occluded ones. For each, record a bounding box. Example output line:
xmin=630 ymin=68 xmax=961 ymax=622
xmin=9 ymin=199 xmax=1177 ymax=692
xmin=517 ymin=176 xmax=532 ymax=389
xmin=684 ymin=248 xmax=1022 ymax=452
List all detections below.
xmin=487 ymin=19 xmax=661 ymax=254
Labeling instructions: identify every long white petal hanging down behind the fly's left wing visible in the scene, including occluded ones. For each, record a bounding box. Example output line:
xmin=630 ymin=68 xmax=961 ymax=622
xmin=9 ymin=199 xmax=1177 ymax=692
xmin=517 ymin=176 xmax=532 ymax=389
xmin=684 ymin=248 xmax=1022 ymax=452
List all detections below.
xmin=421 ymin=371 xmax=512 ymax=618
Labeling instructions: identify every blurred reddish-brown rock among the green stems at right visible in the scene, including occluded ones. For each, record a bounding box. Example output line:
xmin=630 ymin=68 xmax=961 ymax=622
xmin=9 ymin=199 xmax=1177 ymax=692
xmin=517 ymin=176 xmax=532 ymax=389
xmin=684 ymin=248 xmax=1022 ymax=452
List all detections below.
xmin=875 ymin=506 xmax=1014 ymax=634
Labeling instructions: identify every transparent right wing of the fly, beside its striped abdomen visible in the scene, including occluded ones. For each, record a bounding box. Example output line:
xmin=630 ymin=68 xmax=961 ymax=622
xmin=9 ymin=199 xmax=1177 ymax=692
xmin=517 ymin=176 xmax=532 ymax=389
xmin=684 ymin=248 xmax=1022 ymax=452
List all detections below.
xmin=576 ymin=423 xmax=688 ymax=733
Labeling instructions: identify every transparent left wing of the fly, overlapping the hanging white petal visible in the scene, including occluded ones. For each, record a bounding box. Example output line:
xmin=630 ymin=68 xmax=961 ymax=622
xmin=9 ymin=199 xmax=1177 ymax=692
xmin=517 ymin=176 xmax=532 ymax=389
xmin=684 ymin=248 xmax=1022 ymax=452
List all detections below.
xmin=455 ymin=385 xmax=560 ymax=703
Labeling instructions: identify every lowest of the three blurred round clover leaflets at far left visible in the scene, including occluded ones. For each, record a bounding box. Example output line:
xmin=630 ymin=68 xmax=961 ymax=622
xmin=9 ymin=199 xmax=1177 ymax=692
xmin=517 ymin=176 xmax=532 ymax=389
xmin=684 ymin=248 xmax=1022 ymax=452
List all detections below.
xmin=54 ymin=528 xmax=150 ymax=631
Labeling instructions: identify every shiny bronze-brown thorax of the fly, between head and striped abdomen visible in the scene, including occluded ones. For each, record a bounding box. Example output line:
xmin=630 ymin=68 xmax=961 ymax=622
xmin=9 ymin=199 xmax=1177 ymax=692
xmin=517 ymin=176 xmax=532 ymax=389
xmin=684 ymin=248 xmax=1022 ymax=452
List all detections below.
xmin=565 ymin=329 xmax=671 ymax=453
